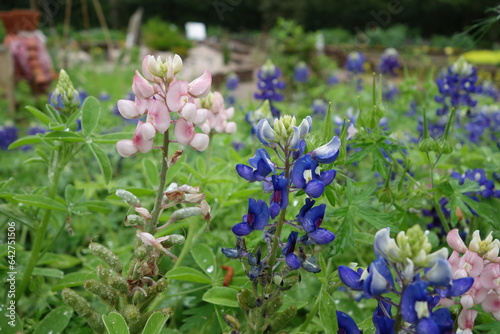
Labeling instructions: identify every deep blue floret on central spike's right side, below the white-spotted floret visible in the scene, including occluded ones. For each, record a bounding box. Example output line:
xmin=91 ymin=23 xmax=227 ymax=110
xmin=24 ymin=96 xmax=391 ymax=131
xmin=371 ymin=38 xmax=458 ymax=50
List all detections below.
xmin=297 ymin=198 xmax=335 ymax=245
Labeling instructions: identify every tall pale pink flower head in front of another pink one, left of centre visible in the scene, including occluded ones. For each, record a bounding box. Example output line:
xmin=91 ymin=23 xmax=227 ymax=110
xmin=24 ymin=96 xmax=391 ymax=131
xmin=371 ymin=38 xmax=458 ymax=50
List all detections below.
xmin=116 ymin=55 xmax=212 ymax=157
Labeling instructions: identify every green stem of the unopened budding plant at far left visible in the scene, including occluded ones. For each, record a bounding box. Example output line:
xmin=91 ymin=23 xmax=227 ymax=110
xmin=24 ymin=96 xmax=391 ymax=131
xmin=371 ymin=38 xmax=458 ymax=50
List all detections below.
xmin=16 ymin=147 xmax=64 ymax=300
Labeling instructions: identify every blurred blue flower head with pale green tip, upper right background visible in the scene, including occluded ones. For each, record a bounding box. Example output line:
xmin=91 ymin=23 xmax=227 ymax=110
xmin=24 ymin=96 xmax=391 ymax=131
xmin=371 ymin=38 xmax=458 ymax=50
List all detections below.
xmin=435 ymin=57 xmax=479 ymax=115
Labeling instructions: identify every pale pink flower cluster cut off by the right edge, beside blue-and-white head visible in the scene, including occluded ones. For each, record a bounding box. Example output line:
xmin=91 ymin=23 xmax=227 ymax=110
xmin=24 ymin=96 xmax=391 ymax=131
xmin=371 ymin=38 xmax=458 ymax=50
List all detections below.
xmin=441 ymin=229 xmax=500 ymax=334
